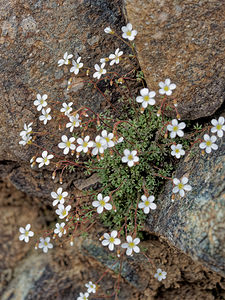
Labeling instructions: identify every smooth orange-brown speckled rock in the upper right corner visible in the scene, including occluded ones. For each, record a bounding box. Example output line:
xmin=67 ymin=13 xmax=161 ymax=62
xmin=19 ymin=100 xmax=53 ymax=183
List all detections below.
xmin=124 ymin=0 xmax=225 ymax=120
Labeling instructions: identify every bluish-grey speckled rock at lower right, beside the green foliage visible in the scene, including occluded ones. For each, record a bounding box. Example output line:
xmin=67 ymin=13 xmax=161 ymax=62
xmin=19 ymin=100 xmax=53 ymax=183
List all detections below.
xmin=147 ymin=136 xmax=225 ymax=276
